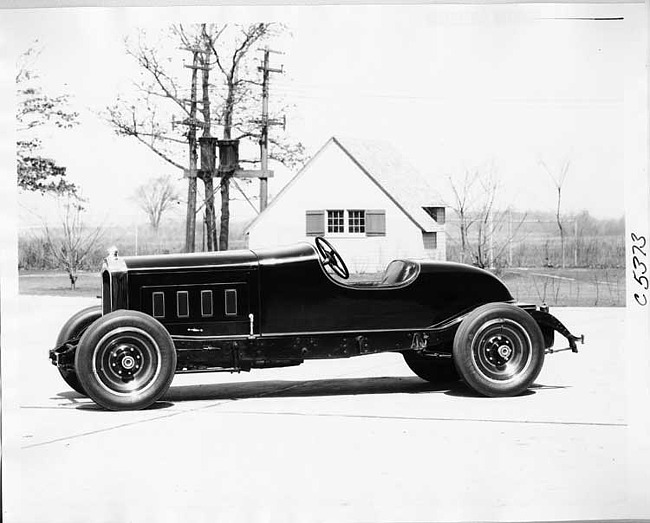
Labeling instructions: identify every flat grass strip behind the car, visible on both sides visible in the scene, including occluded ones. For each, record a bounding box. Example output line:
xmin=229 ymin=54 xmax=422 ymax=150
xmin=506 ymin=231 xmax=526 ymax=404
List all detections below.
xmin=19 ymin=268 xmax=625 ymax=307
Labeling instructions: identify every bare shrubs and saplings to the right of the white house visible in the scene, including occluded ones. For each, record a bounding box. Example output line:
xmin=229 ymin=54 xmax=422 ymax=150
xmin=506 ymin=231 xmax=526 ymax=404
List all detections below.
xmin=447 ymin=159 xmax=625 ymax=270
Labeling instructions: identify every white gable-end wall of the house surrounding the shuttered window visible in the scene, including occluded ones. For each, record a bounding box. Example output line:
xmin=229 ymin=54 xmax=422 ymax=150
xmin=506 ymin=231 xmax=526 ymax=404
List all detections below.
xmin=248 ymin=142 xmax=445 ymax=272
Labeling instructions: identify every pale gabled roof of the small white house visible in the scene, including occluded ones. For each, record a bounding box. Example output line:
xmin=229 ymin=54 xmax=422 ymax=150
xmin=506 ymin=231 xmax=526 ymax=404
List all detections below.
xmin=245 ymin=136 xmax=445 ymax=232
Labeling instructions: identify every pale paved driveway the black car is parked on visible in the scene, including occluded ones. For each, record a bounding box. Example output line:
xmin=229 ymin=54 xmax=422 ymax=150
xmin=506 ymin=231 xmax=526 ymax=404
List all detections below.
xmin=2 ymin=296 xmax=650 ymax=523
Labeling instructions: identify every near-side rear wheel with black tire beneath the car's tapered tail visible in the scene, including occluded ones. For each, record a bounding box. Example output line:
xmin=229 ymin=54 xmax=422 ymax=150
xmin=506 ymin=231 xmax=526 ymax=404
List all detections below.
xmin=453 ymin=303 xmax=544 ymax=397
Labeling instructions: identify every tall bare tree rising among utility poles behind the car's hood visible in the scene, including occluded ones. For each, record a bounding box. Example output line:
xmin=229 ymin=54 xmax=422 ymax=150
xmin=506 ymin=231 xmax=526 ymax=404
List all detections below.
xmin=107 ymin=23 xmax=304 ymax=250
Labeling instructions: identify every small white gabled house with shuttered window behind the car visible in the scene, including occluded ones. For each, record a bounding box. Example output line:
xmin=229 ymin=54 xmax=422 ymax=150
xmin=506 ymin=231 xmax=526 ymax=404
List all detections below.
xmin=245 ymin=137 xmax=446 ymax=272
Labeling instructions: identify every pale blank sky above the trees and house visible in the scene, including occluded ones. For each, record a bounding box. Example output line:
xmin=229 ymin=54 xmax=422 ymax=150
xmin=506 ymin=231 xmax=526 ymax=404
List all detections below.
xmin=0 ymin=4 xmax=646 ymax=227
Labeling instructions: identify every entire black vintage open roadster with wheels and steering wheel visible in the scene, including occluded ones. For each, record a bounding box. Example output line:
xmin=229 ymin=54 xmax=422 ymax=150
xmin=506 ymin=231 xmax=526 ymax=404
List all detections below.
xmin=50 ymin=237 xmax=584 ymax=410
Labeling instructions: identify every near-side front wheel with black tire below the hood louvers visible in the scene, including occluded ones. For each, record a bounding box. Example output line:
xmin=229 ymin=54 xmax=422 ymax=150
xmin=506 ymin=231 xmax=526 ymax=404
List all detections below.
xmin=75 ymin=310 xmax=176 ymax=410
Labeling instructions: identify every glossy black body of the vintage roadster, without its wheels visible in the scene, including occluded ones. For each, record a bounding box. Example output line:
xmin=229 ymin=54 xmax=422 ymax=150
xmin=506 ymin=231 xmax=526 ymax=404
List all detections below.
xmin=91 ymin=243 xmax=554 ymax=372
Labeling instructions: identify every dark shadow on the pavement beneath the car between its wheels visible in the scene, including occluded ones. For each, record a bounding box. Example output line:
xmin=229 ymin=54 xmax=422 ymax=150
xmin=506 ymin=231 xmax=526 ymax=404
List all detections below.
xmin=163 ymin=377 xmax=461 ymax=401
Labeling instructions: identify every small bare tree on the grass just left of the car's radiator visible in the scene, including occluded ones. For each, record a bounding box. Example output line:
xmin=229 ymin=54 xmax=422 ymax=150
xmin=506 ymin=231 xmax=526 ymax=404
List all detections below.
xmin=44 ymin=196 xmax=103 ymax=289
